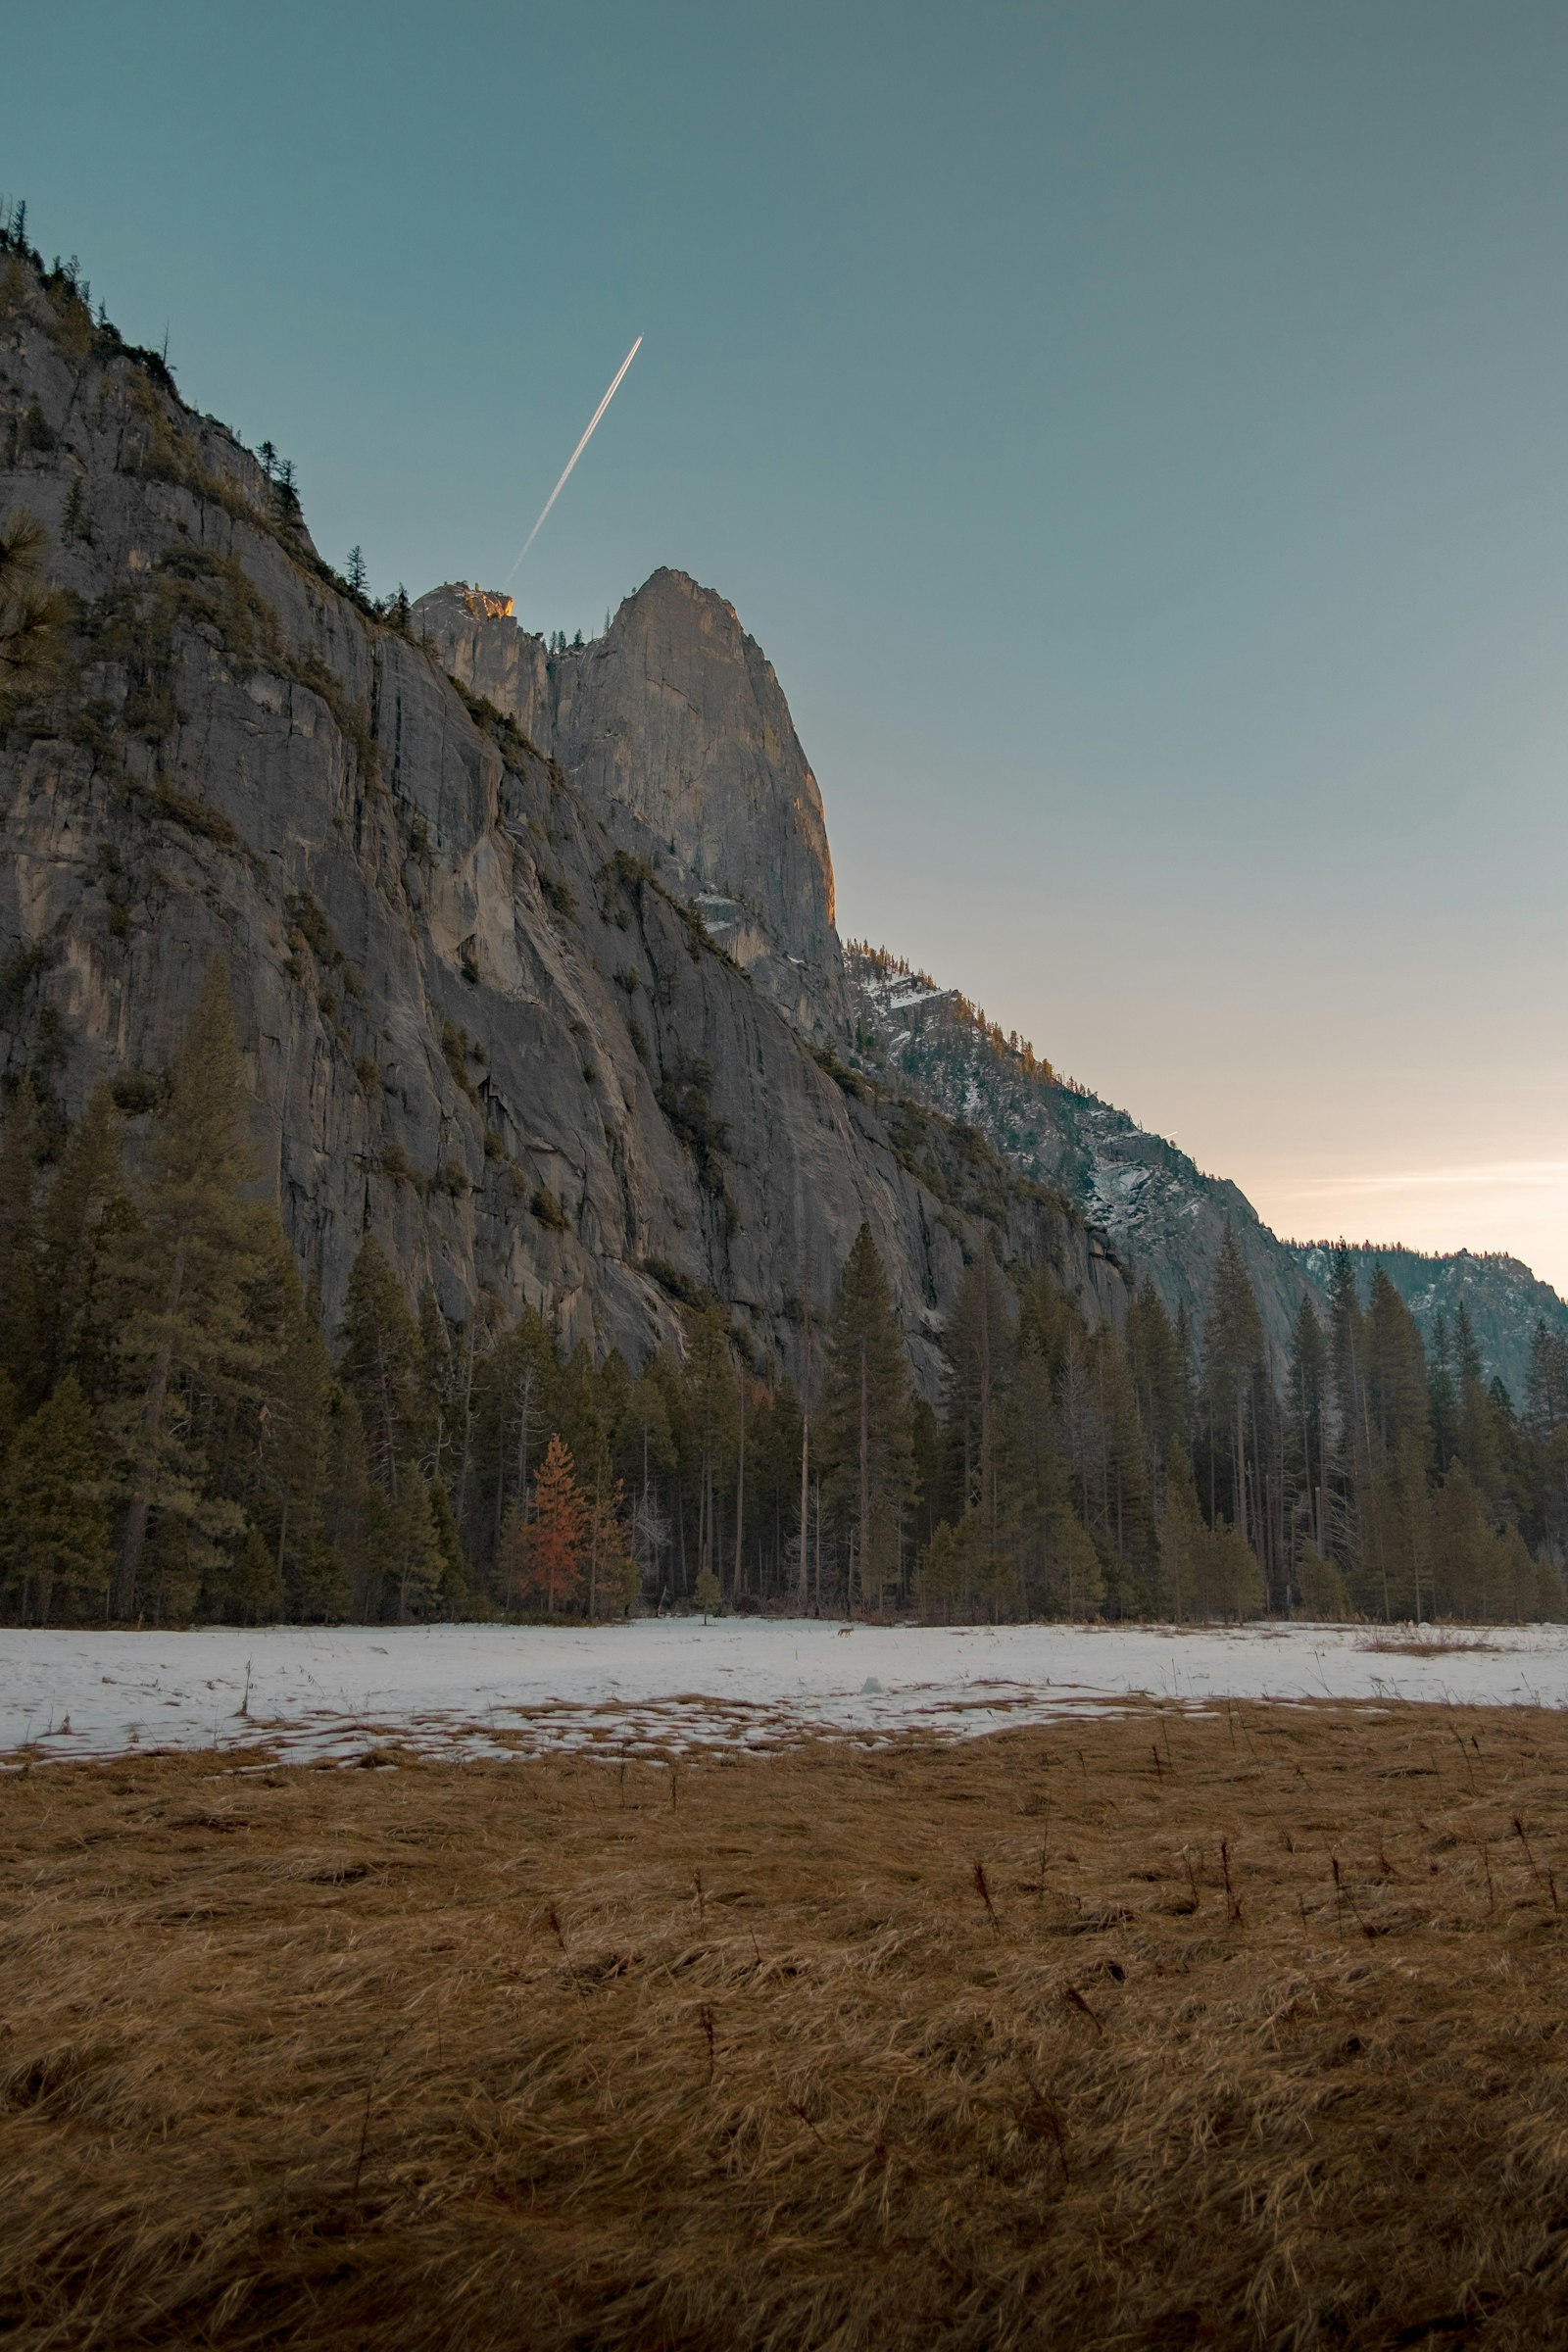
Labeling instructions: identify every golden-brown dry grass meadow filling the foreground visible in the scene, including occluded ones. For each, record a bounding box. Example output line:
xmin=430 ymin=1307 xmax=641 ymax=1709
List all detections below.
xmin=0 ymin=1705 xmax=1568 ymax=2352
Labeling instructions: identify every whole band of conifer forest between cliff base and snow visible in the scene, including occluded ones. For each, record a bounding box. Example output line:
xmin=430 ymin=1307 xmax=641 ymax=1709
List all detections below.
xmin=0 ymin=966 xmax=1568 ymax=1625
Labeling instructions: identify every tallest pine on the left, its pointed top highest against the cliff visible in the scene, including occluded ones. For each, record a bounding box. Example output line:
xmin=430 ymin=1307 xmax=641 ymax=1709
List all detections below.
xmin=108 ymin=962 xmax=264 ymax=1618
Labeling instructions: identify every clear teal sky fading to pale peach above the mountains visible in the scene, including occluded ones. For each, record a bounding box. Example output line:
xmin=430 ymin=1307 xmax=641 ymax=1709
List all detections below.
xmin=0 ymin=0 xmax=1568 ymax=1289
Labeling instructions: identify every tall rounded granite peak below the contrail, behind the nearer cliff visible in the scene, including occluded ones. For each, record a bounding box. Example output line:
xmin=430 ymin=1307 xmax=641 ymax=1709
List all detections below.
xmin=414 ymin=571 xmax=847 ymax=1035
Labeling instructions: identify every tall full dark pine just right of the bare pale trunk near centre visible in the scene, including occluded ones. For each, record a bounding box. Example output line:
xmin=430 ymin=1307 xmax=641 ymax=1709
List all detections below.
xmin=820 ymin=1225 xmax=914 ymax=1609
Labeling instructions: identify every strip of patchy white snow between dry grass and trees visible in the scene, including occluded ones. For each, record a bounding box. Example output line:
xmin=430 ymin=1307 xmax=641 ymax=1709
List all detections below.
xmin=0 ymin=1618 xmax=1568 ymax=1764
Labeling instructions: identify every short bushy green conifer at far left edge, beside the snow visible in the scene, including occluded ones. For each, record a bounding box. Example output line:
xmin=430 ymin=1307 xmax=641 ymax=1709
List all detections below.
xmin=0 ymin=1374 xmax=111 ymax=1625
